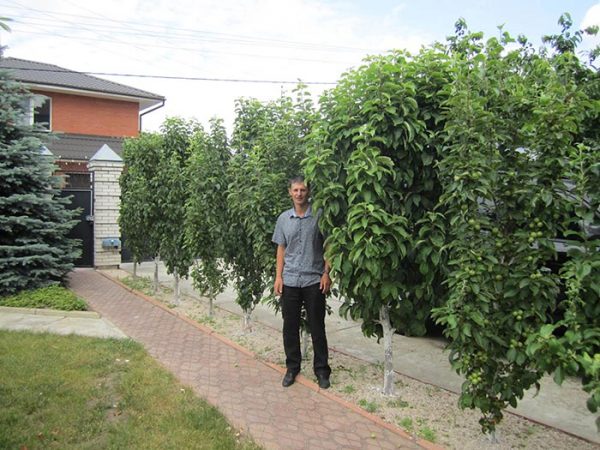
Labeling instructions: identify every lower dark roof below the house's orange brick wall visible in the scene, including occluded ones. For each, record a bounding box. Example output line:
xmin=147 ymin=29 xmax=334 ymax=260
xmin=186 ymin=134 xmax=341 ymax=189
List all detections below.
xmin=46 ymin=133 xmax=123 ymax=161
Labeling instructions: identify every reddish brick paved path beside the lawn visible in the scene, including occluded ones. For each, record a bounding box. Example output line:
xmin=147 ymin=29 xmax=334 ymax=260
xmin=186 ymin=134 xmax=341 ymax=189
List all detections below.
xmin=70 ymin=269 xmax=430 ymax=450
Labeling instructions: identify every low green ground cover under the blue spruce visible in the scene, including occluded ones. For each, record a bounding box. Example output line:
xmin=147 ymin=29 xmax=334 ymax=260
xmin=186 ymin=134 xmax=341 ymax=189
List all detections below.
xmin=0 ymin=285 xmax=87 ymax=311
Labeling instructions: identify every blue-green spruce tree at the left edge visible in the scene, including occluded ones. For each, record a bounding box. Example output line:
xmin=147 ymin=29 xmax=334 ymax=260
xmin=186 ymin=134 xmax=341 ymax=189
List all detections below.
xmin=0 ymin=71 xmax=80 ymax=295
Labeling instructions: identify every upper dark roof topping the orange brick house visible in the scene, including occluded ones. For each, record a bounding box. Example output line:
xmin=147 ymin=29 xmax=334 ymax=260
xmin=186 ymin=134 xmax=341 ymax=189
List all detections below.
xmin=0 ymin=58 xmax=165 ymax=109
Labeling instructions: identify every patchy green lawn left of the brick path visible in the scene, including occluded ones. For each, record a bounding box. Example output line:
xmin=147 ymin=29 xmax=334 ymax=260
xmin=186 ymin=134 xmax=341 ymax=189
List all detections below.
xmin=0 ymin=331 xmax=259 ymax=449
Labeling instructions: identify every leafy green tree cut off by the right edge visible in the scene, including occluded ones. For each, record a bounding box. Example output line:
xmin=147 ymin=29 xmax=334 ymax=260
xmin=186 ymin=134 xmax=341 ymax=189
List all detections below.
xmin=526 ymin=14 xmax=600 ymax=430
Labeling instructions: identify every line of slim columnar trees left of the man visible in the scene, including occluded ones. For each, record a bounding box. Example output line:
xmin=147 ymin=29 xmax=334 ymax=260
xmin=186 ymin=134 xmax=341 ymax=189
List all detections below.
xmin=119 ymin=86 xmax=315 ymax=327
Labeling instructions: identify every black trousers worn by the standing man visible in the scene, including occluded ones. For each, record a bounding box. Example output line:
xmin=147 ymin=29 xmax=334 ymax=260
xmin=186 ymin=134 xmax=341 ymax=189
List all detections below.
xmin=281 ymin=283 xmax=331 ymax=377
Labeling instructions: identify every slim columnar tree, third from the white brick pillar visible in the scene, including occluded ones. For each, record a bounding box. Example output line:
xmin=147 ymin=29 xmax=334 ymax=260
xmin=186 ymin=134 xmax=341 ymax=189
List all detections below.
xmin=186 ymin=119 xmax=231 ymax=316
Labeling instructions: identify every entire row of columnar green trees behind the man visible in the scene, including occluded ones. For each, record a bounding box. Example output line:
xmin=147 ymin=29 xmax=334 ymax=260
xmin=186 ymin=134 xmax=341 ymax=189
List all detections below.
xmin=121 ymin=15 xmax=600 ymax=432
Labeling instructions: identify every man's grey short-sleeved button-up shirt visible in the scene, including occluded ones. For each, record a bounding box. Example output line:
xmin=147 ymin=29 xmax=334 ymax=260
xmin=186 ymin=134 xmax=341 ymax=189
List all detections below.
xmin=272 ymin=205 xmax=325 ymax=287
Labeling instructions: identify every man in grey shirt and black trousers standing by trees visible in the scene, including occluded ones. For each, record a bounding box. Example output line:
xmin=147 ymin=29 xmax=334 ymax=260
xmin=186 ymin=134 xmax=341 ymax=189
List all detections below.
xmin=273 ymin=177 xmax=331 ymax=389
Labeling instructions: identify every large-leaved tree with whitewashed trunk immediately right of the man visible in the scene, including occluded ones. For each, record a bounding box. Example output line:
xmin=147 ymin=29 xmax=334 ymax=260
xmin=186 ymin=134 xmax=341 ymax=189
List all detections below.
xmin=304 ymin=48 xmax=449 ymax=395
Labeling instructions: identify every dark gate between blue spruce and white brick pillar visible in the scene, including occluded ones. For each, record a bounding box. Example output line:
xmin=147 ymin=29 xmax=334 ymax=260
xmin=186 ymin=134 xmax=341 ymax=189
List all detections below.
xmin=61 ymin=189 xmax=94 ymax=267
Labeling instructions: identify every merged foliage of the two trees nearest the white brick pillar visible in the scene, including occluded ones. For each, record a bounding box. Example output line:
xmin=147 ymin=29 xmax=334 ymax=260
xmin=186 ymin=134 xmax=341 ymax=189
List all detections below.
xmin=119 ymin=118 xmax=202 ymax=298
